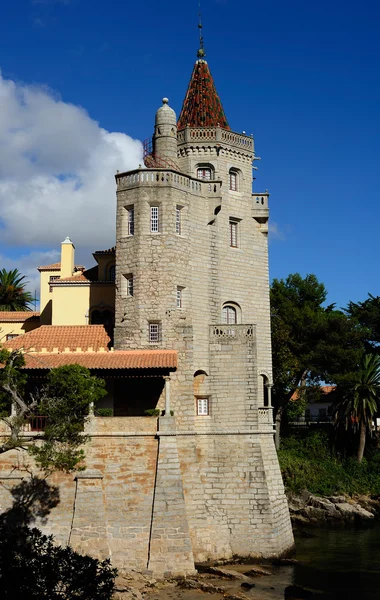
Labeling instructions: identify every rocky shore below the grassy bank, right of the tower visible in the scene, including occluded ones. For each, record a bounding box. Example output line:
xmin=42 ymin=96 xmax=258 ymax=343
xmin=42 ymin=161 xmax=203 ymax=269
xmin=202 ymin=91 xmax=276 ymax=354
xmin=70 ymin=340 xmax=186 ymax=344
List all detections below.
xmin=288 ymin=490 xmax=380 ymax=528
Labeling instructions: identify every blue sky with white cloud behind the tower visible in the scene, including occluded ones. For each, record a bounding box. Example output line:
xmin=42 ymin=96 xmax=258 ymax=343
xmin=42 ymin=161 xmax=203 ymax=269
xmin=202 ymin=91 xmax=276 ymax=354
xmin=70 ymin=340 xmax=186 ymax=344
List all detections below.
xmin=0 ymin=0 xmax=380 ymax=306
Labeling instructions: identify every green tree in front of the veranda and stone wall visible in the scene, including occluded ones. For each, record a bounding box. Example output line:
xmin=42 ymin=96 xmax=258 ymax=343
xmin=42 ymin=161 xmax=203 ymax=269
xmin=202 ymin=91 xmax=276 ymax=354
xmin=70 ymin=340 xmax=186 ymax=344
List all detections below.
xmin=0 ymin=349 xmax=106 ymax=473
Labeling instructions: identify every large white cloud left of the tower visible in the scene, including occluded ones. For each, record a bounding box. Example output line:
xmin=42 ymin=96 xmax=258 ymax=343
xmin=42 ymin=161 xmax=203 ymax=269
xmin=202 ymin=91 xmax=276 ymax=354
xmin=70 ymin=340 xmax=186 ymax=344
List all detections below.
xmin=0 ymin=73 xmax=142 ymax=250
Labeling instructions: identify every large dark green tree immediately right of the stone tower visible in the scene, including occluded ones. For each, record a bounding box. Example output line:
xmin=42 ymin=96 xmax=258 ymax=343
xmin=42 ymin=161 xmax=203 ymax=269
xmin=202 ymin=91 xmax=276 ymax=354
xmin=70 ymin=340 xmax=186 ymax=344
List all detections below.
xmin=270 ymin=273 xmax=364 ymax=448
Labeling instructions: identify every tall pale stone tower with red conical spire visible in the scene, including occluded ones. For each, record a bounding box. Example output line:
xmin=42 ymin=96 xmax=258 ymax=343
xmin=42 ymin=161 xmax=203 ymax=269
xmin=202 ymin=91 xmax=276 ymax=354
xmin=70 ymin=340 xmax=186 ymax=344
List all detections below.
xmin=115 ymin=53 xmax=293 ymax=572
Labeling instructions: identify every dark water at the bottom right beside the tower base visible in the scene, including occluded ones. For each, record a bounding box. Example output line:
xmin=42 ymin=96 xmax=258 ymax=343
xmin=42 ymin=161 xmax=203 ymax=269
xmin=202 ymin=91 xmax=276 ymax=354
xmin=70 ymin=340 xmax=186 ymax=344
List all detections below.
xmin=292 ymin=524 xmax=380 ymax=600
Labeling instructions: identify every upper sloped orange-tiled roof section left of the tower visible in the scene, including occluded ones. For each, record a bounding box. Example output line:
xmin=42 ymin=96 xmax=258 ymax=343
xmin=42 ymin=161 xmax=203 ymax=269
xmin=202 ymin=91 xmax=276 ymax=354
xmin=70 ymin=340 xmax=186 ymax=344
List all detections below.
xmin=4 ymin=325 xmax=111 ymax=352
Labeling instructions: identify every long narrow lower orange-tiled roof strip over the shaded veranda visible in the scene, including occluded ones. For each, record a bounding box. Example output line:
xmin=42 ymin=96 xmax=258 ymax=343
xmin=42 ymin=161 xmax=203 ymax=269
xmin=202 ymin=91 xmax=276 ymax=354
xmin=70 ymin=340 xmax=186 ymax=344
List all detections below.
xmin=13 ymin=350 xmax=177 ymax=370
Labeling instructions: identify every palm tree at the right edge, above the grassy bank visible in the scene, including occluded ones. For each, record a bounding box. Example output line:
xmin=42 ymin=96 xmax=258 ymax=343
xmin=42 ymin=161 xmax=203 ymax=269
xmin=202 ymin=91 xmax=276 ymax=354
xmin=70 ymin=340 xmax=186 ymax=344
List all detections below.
xmin=335 ymin=354 xmax=380 ymax=463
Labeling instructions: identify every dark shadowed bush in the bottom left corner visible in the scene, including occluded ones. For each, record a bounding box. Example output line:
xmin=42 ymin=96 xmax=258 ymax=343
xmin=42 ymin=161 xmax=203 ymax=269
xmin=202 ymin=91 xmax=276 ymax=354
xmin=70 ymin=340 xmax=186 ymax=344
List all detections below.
xmin=0 ymin=523 xmax=116 ymax=600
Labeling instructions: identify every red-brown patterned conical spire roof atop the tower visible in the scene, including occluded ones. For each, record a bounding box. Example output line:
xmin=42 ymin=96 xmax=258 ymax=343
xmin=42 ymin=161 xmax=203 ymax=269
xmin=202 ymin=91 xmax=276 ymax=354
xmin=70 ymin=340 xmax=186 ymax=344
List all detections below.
xmin=178 ymin=60 xmax=230 ymax=129
